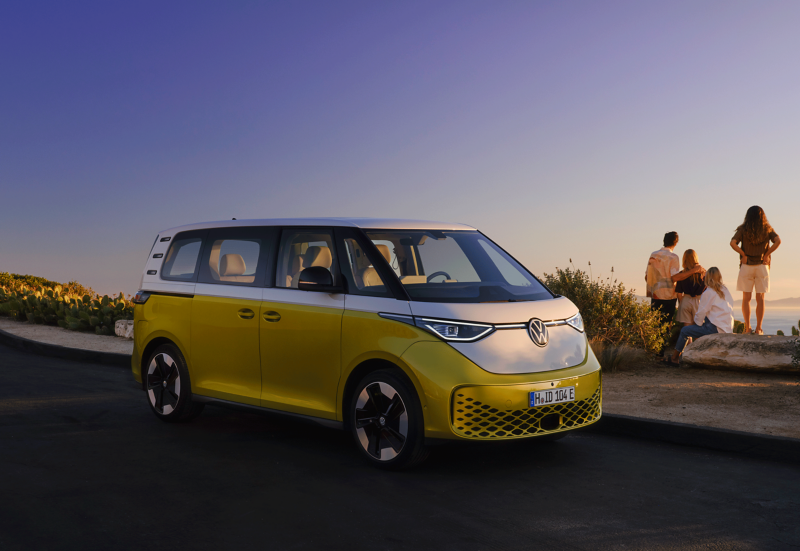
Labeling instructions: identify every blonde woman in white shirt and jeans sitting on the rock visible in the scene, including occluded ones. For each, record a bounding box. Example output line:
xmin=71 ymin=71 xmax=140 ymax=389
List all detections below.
xmin=664 ymin=267 xmax=733 ymax=366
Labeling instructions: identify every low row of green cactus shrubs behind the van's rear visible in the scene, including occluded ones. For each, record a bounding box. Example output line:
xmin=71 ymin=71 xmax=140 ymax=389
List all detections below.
xmin=0 ymin=273 xmax=133 ymax=335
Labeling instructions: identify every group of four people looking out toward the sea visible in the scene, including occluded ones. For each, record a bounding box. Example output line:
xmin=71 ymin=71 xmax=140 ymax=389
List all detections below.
xmin=645 ymin=206 xmax=781 ymax=366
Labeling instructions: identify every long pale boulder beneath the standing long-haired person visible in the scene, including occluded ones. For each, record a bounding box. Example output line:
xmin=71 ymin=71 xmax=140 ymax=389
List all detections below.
xmin=681 ymin=333 xmax=800 ymax=373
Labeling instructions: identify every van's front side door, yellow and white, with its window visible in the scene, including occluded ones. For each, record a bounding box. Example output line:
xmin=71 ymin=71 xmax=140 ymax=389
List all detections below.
xmin=259 ymin=228 xmax=344 ymax=419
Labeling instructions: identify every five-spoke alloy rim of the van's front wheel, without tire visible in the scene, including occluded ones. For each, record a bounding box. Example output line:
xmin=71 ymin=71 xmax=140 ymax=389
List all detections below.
xmin=355 ymin=382 xmax=408 ymax=461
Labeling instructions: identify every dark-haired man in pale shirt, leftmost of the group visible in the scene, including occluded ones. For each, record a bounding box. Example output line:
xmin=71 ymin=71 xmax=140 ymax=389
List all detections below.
xmin=644 ymin=231 xmax=703 ymax=353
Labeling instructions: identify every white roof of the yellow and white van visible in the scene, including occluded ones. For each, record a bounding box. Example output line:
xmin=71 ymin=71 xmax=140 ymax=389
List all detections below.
xmin=159 ymin=218 xmax=475 ymax=235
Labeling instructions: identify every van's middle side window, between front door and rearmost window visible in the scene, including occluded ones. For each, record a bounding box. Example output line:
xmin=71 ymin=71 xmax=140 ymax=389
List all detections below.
xmin=199 ymin=228 xmax=266 ymax=285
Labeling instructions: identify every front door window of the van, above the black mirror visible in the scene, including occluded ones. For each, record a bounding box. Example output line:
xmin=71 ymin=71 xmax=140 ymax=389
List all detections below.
xmin=275 ymin=230 xmax=337 ymax=289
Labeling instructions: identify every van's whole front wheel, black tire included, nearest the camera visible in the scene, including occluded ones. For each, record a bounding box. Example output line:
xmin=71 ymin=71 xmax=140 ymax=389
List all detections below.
xmin=349 ymin=369 xmax=428 ymax=471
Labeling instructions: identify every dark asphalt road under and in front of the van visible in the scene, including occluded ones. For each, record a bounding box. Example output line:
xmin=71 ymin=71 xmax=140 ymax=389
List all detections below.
xmin=0 ymin=346 xmax=800 ymax=551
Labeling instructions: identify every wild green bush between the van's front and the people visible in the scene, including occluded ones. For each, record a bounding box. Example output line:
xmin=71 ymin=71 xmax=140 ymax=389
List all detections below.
xmin=543 ymin=268 xmax=669 ymax=352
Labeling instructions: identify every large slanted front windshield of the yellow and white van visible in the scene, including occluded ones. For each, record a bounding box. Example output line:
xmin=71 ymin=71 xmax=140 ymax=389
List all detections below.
xmin=366 ymin=230 xmax=553 ymax=303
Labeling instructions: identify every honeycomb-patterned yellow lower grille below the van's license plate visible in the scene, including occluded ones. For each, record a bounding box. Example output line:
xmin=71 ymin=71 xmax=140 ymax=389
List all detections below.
xmin=453 ymin=387 xmax=601 ymax=438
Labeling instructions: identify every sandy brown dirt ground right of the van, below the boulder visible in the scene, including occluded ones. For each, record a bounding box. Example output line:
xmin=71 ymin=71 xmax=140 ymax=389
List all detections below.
xmin=603 ymin=359 xmax=800 ymax=438
